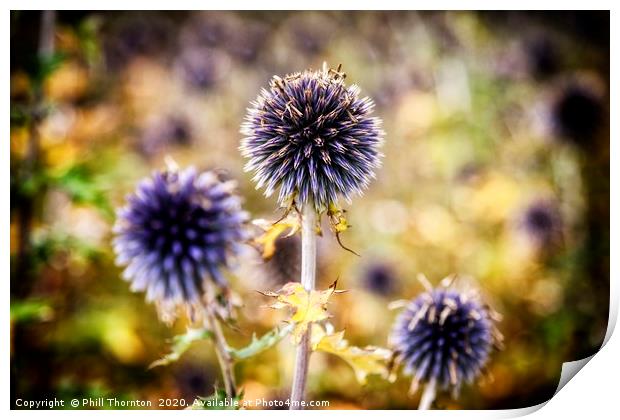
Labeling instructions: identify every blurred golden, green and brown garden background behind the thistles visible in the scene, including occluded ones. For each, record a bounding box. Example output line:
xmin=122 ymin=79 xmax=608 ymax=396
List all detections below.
xmin=10 ymin=11 xmax=609 ymax=409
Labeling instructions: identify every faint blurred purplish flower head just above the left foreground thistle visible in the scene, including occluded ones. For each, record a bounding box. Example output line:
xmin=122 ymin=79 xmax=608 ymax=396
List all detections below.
xmin=138 ymin=115 xmax=192 ymax=156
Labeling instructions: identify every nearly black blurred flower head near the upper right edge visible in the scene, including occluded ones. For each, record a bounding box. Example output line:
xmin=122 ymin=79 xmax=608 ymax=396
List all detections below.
xmin=552 ymin=83 xmax=603 ymax=146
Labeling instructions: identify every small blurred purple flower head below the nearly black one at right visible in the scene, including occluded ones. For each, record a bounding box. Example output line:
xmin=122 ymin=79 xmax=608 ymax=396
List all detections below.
xmin=519 ymin=199 xmax=562 ymax=248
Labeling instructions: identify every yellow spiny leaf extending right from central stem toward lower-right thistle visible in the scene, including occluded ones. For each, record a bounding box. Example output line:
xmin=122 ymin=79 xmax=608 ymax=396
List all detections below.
xmin=312 ymin=324 xmax=392 ymax=384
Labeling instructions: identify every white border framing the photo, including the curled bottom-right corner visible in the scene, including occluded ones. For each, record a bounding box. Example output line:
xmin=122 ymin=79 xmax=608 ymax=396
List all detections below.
xmin=0 ymin=0 xmax=620 ymax=419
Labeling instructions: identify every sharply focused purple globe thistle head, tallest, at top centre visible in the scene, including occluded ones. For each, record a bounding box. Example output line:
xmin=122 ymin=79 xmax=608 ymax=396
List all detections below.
xmin=240 ymin=66 xmax=383 ymax=213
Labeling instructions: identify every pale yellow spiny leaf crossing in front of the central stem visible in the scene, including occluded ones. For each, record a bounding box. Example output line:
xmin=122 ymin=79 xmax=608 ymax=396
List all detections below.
xmin=263 ymin=282 xmax=344 ymax=343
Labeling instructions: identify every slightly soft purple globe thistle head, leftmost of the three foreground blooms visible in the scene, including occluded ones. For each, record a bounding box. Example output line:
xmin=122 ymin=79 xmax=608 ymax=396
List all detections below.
xmin=114 ymin=167 xmax=248 ymax=321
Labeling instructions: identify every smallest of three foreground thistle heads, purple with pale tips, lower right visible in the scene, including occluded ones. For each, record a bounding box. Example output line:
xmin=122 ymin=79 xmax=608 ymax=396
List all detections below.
xmin=389 ymin=278 xmax=501 ymax=395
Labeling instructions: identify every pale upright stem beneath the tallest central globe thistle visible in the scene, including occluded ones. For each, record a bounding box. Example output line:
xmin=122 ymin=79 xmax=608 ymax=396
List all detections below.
xmin=291 ymin=203 xmax=316 ymax=410
